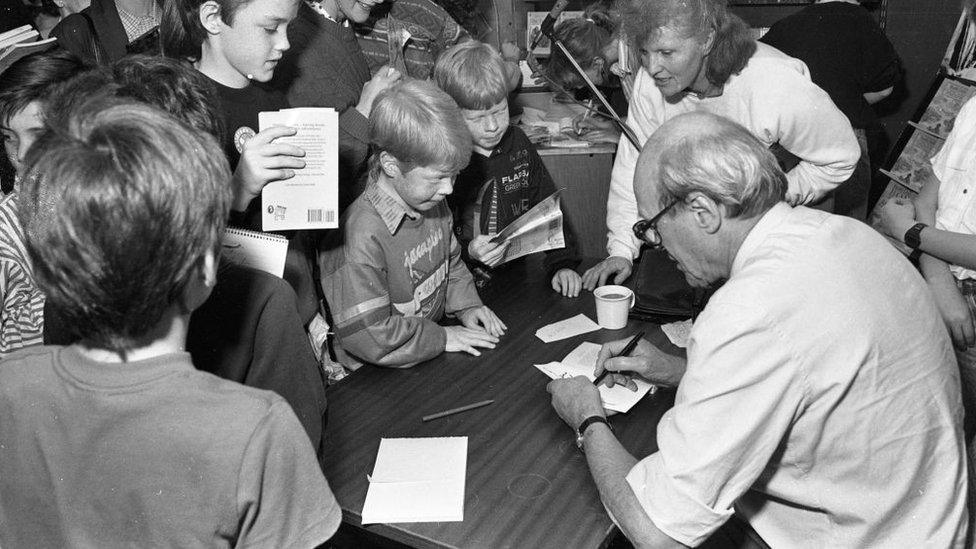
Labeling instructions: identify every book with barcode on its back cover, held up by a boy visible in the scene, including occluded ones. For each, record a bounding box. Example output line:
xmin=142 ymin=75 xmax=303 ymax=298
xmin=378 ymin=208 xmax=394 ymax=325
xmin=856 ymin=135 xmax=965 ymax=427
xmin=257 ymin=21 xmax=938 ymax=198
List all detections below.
xmin=258 ymin=108 xmax=339 ymax=231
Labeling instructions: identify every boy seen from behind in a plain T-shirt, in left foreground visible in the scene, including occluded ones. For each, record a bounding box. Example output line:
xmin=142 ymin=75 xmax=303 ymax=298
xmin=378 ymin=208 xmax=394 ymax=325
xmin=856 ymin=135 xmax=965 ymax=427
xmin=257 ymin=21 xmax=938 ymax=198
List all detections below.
xmin=0 ymin=100 xmax=341 ymax=547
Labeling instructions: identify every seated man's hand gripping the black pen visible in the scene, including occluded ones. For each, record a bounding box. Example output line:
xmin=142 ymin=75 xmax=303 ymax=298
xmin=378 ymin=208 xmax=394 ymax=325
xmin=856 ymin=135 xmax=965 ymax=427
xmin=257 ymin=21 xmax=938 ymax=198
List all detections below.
xmin=593 ymin=338 xmax=687 ymax=391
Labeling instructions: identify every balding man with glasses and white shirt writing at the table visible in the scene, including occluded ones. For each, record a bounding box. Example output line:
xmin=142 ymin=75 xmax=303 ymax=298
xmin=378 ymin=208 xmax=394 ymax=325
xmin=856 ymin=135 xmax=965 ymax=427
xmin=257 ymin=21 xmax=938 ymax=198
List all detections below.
xmin=549 ymin=109 xmax=967 ymax=547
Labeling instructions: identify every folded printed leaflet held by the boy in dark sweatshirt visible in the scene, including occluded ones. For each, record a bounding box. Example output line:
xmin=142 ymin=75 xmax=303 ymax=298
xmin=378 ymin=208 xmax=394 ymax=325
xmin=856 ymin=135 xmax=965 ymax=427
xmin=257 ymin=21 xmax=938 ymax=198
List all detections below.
xmin=491 ymin=191 xmax=566 ymax=263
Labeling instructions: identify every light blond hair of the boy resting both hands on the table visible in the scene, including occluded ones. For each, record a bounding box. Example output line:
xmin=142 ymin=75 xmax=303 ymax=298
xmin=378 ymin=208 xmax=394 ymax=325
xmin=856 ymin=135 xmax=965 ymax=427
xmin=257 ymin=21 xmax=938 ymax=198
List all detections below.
xmin=369 ymin=80 xmax=471 ymax=175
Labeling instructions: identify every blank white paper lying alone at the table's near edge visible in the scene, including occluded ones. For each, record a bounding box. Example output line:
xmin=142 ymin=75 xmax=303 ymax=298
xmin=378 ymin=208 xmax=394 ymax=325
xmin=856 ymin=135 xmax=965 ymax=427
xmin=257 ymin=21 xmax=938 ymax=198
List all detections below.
xmin=362 ymin=437 xmax=468 ymax=524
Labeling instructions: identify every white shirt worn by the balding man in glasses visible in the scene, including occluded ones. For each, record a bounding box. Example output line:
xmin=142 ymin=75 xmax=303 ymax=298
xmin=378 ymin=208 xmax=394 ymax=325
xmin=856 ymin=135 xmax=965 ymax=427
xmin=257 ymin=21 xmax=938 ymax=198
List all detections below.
xmin=627 ymin=203 xmax=967 ymax=548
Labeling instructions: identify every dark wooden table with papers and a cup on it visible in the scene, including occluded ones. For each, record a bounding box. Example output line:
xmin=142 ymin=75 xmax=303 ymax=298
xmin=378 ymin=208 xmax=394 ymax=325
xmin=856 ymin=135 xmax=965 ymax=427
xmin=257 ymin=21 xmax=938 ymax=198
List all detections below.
xmin=326 ymin=258 xmax=680 ymax=549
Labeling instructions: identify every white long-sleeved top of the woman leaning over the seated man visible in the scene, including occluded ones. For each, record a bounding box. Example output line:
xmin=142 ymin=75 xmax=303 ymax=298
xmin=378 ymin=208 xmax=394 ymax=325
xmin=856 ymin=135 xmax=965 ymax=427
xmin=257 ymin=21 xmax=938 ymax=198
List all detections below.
xmin=607 ymin=43 xmax=861 ymax=259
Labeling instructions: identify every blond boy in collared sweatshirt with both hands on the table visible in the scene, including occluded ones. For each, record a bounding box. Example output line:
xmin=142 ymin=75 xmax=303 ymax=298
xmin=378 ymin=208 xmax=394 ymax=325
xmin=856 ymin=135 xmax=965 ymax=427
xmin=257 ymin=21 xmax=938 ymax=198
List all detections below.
xmin=319 ymin=80 xmax=506 ymax=368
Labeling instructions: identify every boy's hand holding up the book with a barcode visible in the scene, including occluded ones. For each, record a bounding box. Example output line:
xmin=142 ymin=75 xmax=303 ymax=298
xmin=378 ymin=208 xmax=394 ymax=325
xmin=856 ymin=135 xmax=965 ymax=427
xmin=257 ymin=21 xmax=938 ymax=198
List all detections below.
xmin=231 ymin=126 xmax=305 ymax=212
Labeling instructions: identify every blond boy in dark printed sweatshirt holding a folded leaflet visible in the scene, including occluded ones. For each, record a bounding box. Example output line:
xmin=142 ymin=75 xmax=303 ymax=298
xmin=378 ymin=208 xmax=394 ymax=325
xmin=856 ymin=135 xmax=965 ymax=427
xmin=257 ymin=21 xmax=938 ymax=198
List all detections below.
xmin=434 ymin=40 xmax=582 ymax=297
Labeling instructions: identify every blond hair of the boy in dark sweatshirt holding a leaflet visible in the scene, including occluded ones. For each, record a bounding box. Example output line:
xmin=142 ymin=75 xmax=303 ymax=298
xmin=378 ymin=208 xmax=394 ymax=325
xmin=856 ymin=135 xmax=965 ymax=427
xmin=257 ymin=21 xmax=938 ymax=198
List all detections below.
xmin=434 ymin=40 xmax=509 ymax=110
